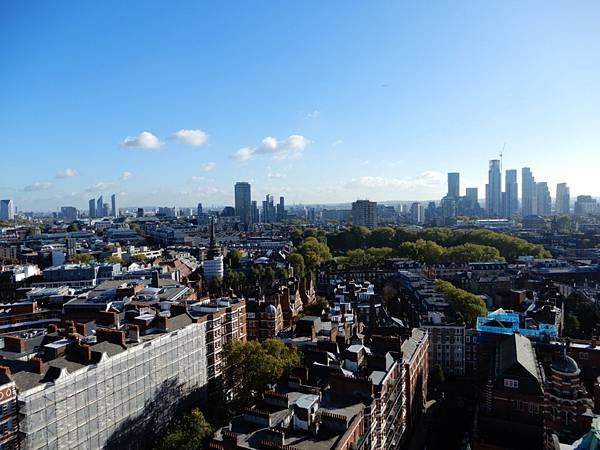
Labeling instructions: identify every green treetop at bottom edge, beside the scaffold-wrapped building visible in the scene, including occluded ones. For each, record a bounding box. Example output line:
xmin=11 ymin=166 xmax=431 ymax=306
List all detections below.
xmin=156 ymin=408 xmax=215 ymax=450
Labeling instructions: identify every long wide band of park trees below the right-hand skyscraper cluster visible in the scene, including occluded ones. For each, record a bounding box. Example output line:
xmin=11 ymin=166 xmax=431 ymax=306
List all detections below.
xmin=326 ymin=227 xmax=550 ymax=261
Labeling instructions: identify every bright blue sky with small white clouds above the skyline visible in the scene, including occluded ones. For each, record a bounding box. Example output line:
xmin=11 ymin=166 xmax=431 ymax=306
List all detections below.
xmin=0 ymin=0 xmax=600 ymax=210
